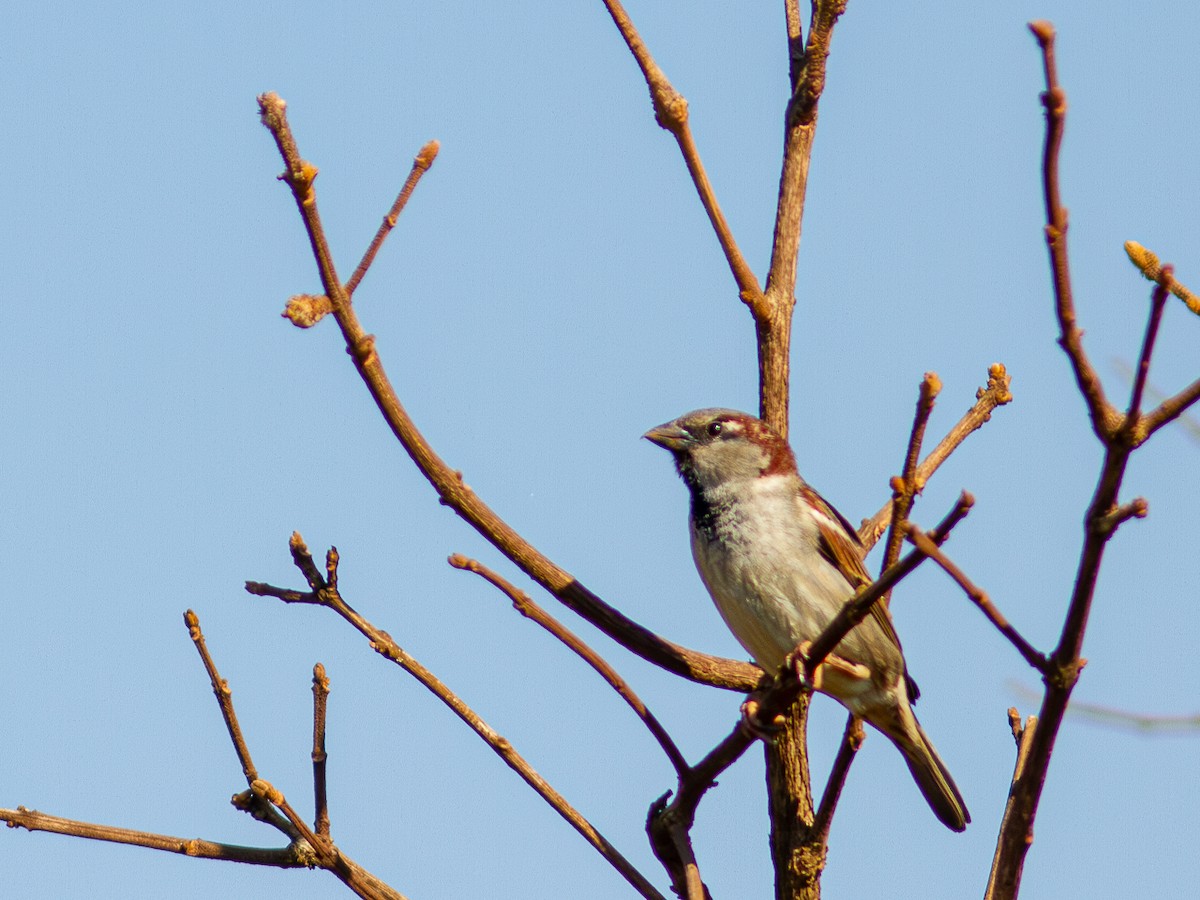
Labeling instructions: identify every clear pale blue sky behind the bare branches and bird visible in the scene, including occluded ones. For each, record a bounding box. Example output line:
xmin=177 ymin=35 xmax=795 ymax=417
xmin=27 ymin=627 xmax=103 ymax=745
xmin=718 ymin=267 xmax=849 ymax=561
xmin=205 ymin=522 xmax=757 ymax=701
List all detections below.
xmin=0 ymin=0 xmax=1200 ymax=900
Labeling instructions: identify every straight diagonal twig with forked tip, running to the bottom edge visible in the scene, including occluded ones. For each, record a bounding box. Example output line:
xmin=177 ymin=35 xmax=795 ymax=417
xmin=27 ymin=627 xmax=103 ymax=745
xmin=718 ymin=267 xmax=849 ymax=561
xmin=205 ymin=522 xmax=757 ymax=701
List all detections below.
xmin=246 ymin=532 xmax=662 ymax=900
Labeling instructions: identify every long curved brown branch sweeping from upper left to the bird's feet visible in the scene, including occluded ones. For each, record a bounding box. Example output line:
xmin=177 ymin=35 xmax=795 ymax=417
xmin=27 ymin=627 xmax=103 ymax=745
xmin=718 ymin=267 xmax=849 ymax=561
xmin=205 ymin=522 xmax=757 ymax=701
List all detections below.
xmin=258 ymin=94 xmax=762 ymax=691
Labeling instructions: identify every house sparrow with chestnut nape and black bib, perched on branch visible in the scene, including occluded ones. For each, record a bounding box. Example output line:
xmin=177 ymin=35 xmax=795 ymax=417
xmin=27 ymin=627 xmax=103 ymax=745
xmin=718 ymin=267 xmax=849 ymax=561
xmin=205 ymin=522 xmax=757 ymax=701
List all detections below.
xmin=644 ymin=409 xmax=971 ymax=832
